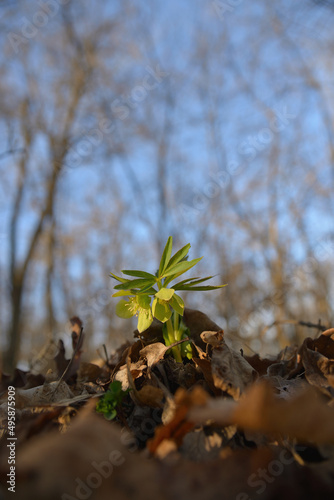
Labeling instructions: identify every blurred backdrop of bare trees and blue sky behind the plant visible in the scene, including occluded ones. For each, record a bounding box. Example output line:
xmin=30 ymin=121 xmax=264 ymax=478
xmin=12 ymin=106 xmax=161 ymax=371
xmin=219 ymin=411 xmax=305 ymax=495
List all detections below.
xmin=0 ymin=0 xmax=334 ymax=369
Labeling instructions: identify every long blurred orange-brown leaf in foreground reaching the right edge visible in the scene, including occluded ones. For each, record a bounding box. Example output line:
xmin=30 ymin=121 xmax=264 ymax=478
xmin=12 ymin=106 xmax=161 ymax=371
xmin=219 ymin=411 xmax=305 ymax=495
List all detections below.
xmin=188 ymin=382 xmax=334 ymax=444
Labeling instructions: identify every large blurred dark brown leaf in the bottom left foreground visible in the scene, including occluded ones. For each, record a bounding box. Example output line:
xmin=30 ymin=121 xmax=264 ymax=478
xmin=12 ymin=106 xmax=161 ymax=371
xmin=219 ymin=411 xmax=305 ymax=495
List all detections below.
xmin=7 ymin=402 xmax=161 ymax=500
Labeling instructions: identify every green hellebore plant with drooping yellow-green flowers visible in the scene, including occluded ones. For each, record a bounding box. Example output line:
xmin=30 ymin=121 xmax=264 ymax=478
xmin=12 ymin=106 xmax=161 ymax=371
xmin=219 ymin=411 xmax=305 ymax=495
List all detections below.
xmin=110 ymin=236 xmax=226 ymax=362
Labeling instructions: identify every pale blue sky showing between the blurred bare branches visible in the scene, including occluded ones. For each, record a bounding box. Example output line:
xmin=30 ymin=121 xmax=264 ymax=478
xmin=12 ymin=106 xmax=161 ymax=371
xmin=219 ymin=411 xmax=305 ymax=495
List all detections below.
xmin=0 ymin=0 xmax=334 ymax=360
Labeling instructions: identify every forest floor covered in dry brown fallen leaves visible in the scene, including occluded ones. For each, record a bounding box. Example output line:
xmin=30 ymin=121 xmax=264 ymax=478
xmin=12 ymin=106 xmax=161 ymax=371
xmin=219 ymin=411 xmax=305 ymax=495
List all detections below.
xmin=0 ymin=310 xmax=334 ymax=500
